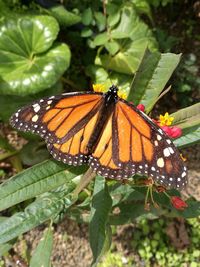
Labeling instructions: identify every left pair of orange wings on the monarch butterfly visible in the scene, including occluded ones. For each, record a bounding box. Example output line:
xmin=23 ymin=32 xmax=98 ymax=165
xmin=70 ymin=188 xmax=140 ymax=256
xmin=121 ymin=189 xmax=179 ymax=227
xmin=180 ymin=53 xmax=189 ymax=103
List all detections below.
xmin=10 ymin=93 xmax=103 ymax=165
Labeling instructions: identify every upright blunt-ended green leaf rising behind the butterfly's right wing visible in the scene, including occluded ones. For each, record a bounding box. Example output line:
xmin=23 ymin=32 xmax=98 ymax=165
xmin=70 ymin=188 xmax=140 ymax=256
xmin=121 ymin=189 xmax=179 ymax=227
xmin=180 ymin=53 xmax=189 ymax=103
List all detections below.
xmin=128 ymin=50 xmax=181 ymax=113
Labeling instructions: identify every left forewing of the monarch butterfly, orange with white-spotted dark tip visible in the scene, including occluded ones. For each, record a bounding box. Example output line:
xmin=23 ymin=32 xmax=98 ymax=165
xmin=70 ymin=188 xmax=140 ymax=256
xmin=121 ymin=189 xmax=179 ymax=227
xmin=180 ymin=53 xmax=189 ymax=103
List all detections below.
xmin=10 ymin=93 xmax=102 ymax=146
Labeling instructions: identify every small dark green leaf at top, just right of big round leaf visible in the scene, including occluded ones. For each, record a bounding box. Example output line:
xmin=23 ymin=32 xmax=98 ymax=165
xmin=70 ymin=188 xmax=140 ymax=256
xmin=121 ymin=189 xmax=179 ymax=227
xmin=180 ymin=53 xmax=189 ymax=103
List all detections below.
xmin=48 ymin=5 xmax=81 ymax=27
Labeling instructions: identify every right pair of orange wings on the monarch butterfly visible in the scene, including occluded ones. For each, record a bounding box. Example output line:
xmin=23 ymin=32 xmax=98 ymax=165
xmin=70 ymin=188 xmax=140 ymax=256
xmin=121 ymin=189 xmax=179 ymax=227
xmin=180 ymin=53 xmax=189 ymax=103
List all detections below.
xmin=90 ymin=99 xmax=187 ymax=189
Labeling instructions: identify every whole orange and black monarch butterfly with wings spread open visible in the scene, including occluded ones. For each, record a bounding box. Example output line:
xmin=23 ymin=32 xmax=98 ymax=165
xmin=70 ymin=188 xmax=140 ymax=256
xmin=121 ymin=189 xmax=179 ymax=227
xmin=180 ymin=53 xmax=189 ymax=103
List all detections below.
xmin=10 ymin=85 xmax=187 ymax=189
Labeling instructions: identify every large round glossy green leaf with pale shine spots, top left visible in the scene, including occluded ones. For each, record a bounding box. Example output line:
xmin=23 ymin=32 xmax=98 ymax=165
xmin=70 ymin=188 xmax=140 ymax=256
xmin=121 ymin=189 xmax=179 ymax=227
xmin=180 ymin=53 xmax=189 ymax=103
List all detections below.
xmin=0 ymin=16 xmax=70 ymax=95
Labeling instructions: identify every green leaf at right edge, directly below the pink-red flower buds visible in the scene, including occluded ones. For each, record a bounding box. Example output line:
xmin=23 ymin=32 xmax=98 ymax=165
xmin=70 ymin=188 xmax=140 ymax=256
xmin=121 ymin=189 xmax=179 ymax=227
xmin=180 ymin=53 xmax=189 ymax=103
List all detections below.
xmin=173 ymin=126 xmax=200 ymax=148
